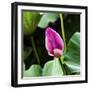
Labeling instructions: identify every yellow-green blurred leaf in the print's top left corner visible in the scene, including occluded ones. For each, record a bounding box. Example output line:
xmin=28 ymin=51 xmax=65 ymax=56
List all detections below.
xmin=22 ymin=11 xmax=41 ymax=35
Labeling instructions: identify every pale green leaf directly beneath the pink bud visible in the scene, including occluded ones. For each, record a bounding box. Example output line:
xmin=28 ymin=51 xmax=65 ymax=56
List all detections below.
xmin=42 ymin=58 xmax=63 ymax=76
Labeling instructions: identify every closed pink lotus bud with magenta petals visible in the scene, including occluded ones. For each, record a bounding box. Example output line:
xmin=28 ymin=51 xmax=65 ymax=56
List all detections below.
xmin=45 ymin=27 xmax=64 ymax=57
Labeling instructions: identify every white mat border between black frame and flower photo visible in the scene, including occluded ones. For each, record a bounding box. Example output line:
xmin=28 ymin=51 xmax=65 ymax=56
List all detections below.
xmin=18 ymin=6 xmax=85 ymax=84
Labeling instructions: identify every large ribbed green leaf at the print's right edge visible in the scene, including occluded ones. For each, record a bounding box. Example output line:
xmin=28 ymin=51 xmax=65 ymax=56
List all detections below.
xmin=63 ymin=32 xmax=80 ymax=74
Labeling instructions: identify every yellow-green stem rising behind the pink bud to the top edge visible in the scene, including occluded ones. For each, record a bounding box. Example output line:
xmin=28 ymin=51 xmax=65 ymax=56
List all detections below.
xmin=59 ymin=13 xmax=66 ymax=52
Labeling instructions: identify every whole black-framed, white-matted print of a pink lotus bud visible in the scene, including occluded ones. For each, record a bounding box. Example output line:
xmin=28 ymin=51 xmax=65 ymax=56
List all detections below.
xmin=11 ymin=2 xmax=87 ymax=87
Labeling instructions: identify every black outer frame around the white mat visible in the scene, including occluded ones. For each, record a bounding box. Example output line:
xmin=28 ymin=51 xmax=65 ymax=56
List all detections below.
xmin=11 ymin=2 xmax=88 ymax=87
